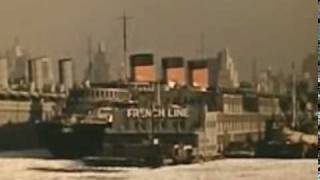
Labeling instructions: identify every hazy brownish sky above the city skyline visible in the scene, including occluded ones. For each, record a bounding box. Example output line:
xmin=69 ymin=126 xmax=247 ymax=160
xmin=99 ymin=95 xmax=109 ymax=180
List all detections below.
xmin=0 ymin=0 xmax=317 ymax=79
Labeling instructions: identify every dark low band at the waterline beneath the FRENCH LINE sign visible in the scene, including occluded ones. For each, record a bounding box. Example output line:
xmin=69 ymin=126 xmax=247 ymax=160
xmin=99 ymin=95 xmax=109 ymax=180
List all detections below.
xmin=101 ymin=132 xmax=198 ymax=165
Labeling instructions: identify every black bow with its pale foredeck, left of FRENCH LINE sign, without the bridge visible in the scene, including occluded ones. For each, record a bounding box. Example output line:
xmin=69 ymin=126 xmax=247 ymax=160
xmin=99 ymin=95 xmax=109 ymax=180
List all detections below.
xmin=35 ymin=107 xmax=110 ymax=158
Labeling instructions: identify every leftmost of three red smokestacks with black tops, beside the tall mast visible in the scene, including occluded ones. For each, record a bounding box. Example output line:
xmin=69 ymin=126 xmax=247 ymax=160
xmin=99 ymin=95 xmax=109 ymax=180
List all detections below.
xmin=130 ymin=54 xmax=156 ymax=82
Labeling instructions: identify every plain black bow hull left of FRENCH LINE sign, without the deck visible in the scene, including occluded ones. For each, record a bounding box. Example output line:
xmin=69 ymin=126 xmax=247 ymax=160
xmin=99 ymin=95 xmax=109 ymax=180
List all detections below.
xmin=36 ymin=122 xmax=105 ymax=158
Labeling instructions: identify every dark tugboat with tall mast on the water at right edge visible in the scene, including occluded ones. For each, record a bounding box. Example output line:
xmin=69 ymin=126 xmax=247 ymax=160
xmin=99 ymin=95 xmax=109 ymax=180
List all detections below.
xmin=256 ymin=66 xmax=318 ymax=158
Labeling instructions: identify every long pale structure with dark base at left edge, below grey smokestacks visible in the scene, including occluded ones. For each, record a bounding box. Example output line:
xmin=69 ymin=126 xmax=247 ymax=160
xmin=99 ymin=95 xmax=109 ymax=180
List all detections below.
xmin=0 ymin=89 xmax=65 ymax=150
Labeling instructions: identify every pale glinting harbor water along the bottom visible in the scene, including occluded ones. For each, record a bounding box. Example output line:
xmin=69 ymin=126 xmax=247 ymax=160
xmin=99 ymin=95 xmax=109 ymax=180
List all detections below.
xmin=0 ymin=151 xmax=317 ymax=180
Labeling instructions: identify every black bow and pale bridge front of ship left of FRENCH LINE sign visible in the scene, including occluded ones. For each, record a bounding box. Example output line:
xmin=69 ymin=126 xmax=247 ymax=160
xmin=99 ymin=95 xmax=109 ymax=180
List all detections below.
xmin=35 ymin=84 xmax=127 ymax=158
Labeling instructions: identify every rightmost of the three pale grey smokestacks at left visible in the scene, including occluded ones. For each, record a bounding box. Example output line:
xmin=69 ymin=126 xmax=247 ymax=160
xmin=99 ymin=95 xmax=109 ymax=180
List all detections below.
xmin=58 ymin=58 xmax=73 ymax=90
